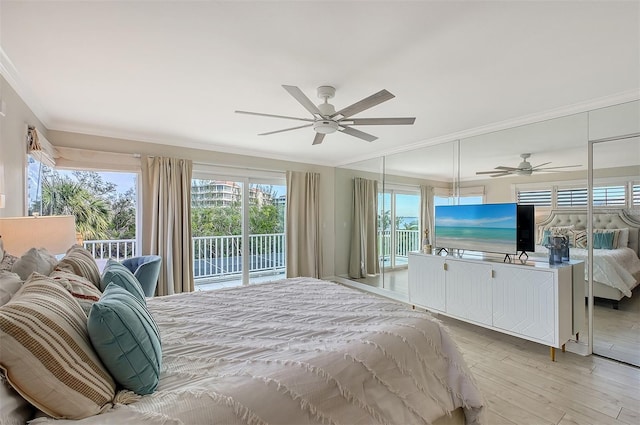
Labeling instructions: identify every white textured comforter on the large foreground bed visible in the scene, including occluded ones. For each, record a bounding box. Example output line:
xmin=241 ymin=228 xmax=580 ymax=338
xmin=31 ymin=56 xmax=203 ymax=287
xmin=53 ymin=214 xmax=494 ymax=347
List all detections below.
xmin=35 ymin=278 xmax=483 ymax=425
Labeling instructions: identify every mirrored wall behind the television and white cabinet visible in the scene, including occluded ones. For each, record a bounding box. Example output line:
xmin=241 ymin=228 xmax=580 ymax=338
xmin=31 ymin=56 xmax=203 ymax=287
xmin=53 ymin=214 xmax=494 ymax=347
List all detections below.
xmin=335 ymin=101 xmax=640 ymax=363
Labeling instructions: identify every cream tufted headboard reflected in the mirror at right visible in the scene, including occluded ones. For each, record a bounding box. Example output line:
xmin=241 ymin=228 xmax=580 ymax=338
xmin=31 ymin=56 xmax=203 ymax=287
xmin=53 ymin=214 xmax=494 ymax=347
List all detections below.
xmin=537 ymin=209 xmax=640 ymax=256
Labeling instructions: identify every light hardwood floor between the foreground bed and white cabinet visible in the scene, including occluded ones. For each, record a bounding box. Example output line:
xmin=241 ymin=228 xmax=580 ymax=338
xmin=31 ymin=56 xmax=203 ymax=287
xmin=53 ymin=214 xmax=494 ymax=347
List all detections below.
xmin=436 ymin=315 xmax=640 ymax=425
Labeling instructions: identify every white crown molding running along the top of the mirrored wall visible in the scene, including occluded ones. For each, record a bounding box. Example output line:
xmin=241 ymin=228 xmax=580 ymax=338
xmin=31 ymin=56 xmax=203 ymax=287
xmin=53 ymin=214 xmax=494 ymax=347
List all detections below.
xmin=334 ymin=89 xmax=640 ymax=167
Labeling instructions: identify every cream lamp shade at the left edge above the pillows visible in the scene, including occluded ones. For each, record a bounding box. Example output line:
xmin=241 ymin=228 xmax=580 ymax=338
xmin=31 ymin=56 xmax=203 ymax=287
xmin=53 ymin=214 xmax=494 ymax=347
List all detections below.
xmin=0 ymin=215 xmax=76 ymax=257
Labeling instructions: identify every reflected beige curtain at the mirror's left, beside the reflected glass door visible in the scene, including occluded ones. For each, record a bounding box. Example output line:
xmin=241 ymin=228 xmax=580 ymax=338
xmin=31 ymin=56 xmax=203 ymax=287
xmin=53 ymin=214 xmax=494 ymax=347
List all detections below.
xmin=349 ymin=177 xmax=380 ymax=279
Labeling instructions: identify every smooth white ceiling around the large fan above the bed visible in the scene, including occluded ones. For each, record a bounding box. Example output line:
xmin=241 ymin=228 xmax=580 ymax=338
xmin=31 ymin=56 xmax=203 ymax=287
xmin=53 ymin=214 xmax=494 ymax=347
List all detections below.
xmin=0 ymin=0 xmax=640 ymax=174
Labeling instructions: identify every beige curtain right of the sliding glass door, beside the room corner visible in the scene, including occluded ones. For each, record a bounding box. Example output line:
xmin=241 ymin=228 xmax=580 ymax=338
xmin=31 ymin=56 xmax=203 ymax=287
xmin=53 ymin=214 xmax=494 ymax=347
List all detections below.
xmin=286 ymin=171 xmax=322 ymax=278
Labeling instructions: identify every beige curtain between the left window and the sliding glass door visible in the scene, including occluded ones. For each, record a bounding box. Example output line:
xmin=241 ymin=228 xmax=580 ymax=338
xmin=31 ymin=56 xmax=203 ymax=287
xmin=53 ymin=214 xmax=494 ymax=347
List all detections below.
xmin=142 ymin=157 xmax=194 ymax=295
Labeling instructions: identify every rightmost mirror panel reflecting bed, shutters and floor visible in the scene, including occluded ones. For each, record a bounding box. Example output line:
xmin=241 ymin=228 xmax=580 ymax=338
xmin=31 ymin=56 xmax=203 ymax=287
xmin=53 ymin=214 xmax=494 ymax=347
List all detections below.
xmin=589 ymin=102 xmax=640 ymax=366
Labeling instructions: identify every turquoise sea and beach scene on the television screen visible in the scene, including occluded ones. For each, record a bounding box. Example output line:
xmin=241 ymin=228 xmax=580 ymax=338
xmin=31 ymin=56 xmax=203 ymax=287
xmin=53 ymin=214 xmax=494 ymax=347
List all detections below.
xmin=435 ymin=204 xmax=517 ymax=254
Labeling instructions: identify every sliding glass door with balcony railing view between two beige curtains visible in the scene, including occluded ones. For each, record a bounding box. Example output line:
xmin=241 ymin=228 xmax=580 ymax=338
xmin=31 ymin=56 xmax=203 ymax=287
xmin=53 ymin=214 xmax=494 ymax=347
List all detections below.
xmin=191 ymin=173 xmax=286 ymax=289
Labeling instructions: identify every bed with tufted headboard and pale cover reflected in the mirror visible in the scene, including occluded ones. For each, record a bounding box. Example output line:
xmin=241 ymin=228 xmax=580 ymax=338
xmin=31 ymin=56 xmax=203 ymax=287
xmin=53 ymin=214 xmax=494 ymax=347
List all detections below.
xmin=529 ymin=209 xmax=640 ymax=308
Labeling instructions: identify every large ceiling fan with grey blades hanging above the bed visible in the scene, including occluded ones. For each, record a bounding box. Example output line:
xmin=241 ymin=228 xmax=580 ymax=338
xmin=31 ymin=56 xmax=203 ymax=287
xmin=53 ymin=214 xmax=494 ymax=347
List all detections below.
xmin=236 ymin=85 xmax=416 ymax=145
